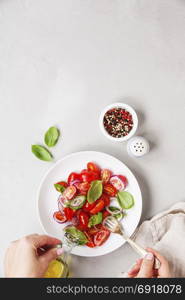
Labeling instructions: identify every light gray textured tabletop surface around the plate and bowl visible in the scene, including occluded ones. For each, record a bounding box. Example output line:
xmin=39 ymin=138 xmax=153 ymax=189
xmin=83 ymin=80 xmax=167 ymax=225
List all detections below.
xmin=0 ymin=0 xmax=185 ymax=277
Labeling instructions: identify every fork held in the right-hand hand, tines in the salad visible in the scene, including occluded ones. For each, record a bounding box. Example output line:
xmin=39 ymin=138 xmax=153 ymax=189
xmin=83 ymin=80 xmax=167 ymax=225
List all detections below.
xmin=103 ymin=216 xmax=161 ymax=269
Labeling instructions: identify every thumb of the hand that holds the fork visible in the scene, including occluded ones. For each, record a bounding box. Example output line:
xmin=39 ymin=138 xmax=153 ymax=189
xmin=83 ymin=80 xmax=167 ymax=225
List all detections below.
xmin=137 ymin=252 xmax=154 ymax=278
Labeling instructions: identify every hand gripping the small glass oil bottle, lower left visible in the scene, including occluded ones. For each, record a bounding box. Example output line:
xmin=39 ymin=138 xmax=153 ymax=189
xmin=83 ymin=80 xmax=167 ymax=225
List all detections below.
xmin=4 ymin=234 xmax=62 ymax=278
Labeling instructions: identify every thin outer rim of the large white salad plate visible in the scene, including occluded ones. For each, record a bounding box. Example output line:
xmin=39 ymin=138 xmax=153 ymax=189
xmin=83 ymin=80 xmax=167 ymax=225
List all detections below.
xmin=36 ymin=150 xmax=143 ymax=257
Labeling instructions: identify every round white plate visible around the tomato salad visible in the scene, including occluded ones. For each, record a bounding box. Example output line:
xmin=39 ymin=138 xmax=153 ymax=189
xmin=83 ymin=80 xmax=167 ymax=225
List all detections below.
xmin=38 ymin=151 xmax=142 ymax=257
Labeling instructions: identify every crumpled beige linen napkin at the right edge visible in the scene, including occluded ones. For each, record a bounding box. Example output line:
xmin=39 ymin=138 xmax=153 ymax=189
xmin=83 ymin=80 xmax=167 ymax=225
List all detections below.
xmin=122 ymin=202 xmax=185 ymax=277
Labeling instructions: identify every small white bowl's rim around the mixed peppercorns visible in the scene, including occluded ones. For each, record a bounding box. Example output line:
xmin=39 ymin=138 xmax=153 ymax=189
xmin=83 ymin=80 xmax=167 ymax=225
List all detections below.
xmin=99 ymin=102 xmax=138 ymax=142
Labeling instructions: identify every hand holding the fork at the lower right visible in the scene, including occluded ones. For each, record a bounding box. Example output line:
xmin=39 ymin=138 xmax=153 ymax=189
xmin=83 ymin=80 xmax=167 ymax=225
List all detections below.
xmin=128 ymin=248 xmax=171 ymax=278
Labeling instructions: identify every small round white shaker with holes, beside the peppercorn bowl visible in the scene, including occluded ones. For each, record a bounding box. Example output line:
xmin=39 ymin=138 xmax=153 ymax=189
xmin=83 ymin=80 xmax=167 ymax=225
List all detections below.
xmin=127 ymin=136 xmax=150 ymax=157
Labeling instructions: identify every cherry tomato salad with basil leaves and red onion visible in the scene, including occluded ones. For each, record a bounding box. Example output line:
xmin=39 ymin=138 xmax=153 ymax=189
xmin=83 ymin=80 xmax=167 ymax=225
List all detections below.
xmin=53 ymin=162 xmax=134 ymax=248
